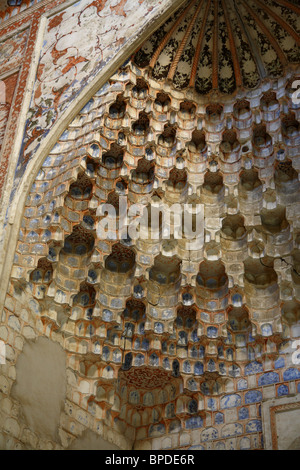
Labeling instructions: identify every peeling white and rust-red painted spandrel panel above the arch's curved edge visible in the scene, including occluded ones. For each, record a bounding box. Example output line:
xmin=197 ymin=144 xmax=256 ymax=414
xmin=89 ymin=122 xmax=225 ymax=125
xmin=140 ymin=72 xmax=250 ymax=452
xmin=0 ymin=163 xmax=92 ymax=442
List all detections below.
xmin=12 ymin=0 xmax=173 ymax=182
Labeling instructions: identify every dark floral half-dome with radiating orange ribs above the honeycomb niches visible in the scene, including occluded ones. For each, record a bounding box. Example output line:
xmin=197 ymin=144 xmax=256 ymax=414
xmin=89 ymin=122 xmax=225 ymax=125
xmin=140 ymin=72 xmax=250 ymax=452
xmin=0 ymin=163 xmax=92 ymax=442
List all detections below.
xmin=134 ymin=0 xmax=300 ymax=96
